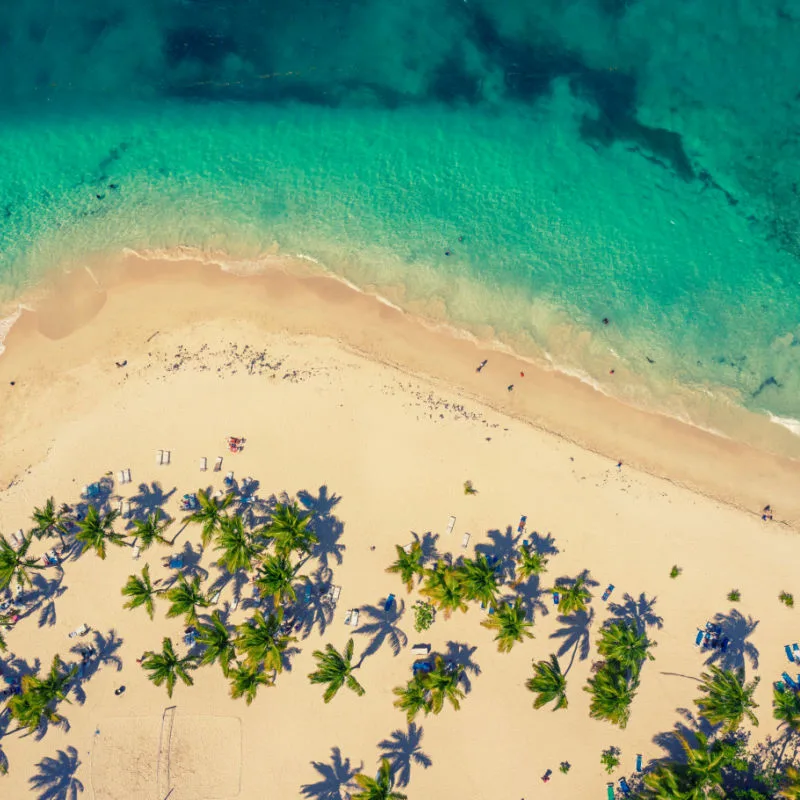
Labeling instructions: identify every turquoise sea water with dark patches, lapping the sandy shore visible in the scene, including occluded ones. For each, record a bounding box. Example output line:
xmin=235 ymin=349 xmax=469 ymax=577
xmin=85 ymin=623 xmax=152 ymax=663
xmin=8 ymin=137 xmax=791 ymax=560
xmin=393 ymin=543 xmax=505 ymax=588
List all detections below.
xmin=0 ymin=0 xmax=800 ymax=438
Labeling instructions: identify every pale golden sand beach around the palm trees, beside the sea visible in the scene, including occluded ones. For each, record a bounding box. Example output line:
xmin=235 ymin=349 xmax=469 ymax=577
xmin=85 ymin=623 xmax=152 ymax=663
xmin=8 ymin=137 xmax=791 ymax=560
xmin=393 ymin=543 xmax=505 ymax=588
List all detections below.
xmin=0 ymin=253 xmax=800 ymax=800
